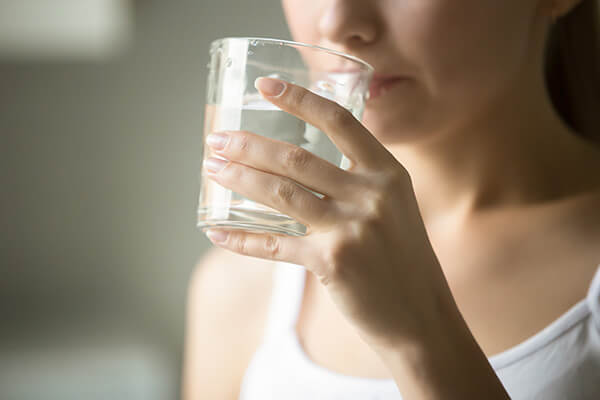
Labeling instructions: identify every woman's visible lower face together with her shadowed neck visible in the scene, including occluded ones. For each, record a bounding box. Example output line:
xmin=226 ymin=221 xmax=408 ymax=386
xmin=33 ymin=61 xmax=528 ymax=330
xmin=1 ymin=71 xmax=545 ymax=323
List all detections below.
xmin=282 ymin=0 xmax=598 ymax=221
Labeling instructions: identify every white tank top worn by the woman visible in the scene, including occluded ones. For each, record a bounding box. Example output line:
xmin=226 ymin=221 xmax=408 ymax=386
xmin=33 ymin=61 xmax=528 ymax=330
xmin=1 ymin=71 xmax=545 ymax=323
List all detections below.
xmin=239 ymin=262 xmax=600 ymax=400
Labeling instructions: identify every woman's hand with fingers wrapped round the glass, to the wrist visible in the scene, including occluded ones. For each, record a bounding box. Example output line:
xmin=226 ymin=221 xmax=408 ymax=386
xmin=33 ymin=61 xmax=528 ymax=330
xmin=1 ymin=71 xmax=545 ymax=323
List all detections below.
xmin=205 ymin=78 xmax=454 ymax=348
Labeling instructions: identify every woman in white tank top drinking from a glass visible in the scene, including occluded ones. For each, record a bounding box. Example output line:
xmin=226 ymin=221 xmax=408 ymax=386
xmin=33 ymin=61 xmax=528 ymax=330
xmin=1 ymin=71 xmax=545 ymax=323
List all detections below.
xmin=183 ymin=0 xmax=600 ymax=400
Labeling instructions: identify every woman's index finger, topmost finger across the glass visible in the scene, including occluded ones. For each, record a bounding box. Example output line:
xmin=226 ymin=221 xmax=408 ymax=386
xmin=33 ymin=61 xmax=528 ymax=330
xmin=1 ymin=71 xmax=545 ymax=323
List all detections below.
xmin=254 ymin=77 xmax=395 ymax=169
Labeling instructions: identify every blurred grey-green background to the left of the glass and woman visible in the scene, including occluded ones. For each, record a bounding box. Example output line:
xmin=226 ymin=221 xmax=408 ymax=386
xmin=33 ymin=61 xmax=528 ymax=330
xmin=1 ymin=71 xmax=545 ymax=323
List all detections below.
xmin=0 ymin=0 xmax=289 ymax=400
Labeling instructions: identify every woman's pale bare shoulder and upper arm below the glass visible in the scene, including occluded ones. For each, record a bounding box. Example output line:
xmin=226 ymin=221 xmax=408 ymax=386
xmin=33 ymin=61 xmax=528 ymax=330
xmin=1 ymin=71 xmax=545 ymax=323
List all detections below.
xmin=183 ymin=247 xmax=275 ymax=400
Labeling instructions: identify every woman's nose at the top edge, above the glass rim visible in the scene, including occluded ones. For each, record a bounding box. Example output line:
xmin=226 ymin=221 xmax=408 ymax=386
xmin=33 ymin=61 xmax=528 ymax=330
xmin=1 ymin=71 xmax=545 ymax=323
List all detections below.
xmin=319 ymin=0 xmax=380 ymax=46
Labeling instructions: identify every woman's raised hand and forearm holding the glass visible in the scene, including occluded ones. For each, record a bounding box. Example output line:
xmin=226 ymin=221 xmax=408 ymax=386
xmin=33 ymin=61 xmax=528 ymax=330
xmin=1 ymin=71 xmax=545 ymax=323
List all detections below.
xmin=206 ymin=79 xmax=508 ymax=400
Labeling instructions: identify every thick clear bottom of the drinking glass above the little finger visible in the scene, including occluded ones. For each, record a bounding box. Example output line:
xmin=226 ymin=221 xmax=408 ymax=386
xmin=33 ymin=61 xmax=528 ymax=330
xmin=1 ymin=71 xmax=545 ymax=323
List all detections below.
xmin=196 ymin=208 xmax=306 ymax=236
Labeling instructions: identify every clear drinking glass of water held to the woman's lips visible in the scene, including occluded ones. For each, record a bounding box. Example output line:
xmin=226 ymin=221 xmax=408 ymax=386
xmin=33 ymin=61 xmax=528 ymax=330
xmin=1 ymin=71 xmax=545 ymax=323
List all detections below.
xmin=197 ymin=37 xmax=373 ymax=236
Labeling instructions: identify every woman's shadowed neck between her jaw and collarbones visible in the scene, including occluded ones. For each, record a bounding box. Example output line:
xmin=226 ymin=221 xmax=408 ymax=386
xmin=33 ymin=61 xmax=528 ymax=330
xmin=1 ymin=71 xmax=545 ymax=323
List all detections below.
xmin=388 ymin=68 xmax=600 ymax=228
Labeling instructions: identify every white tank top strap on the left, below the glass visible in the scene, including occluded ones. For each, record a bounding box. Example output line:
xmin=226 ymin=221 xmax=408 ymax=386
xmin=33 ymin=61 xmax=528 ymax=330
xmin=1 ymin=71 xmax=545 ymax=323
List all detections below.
xmin=264 ymin=261 xmax=306 ymax=341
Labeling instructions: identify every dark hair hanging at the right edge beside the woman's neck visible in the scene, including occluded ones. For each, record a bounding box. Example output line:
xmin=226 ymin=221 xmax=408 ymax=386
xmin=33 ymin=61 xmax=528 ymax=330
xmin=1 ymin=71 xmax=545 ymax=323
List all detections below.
xmin=545 ymin=0 xmax=600 ymax=145
